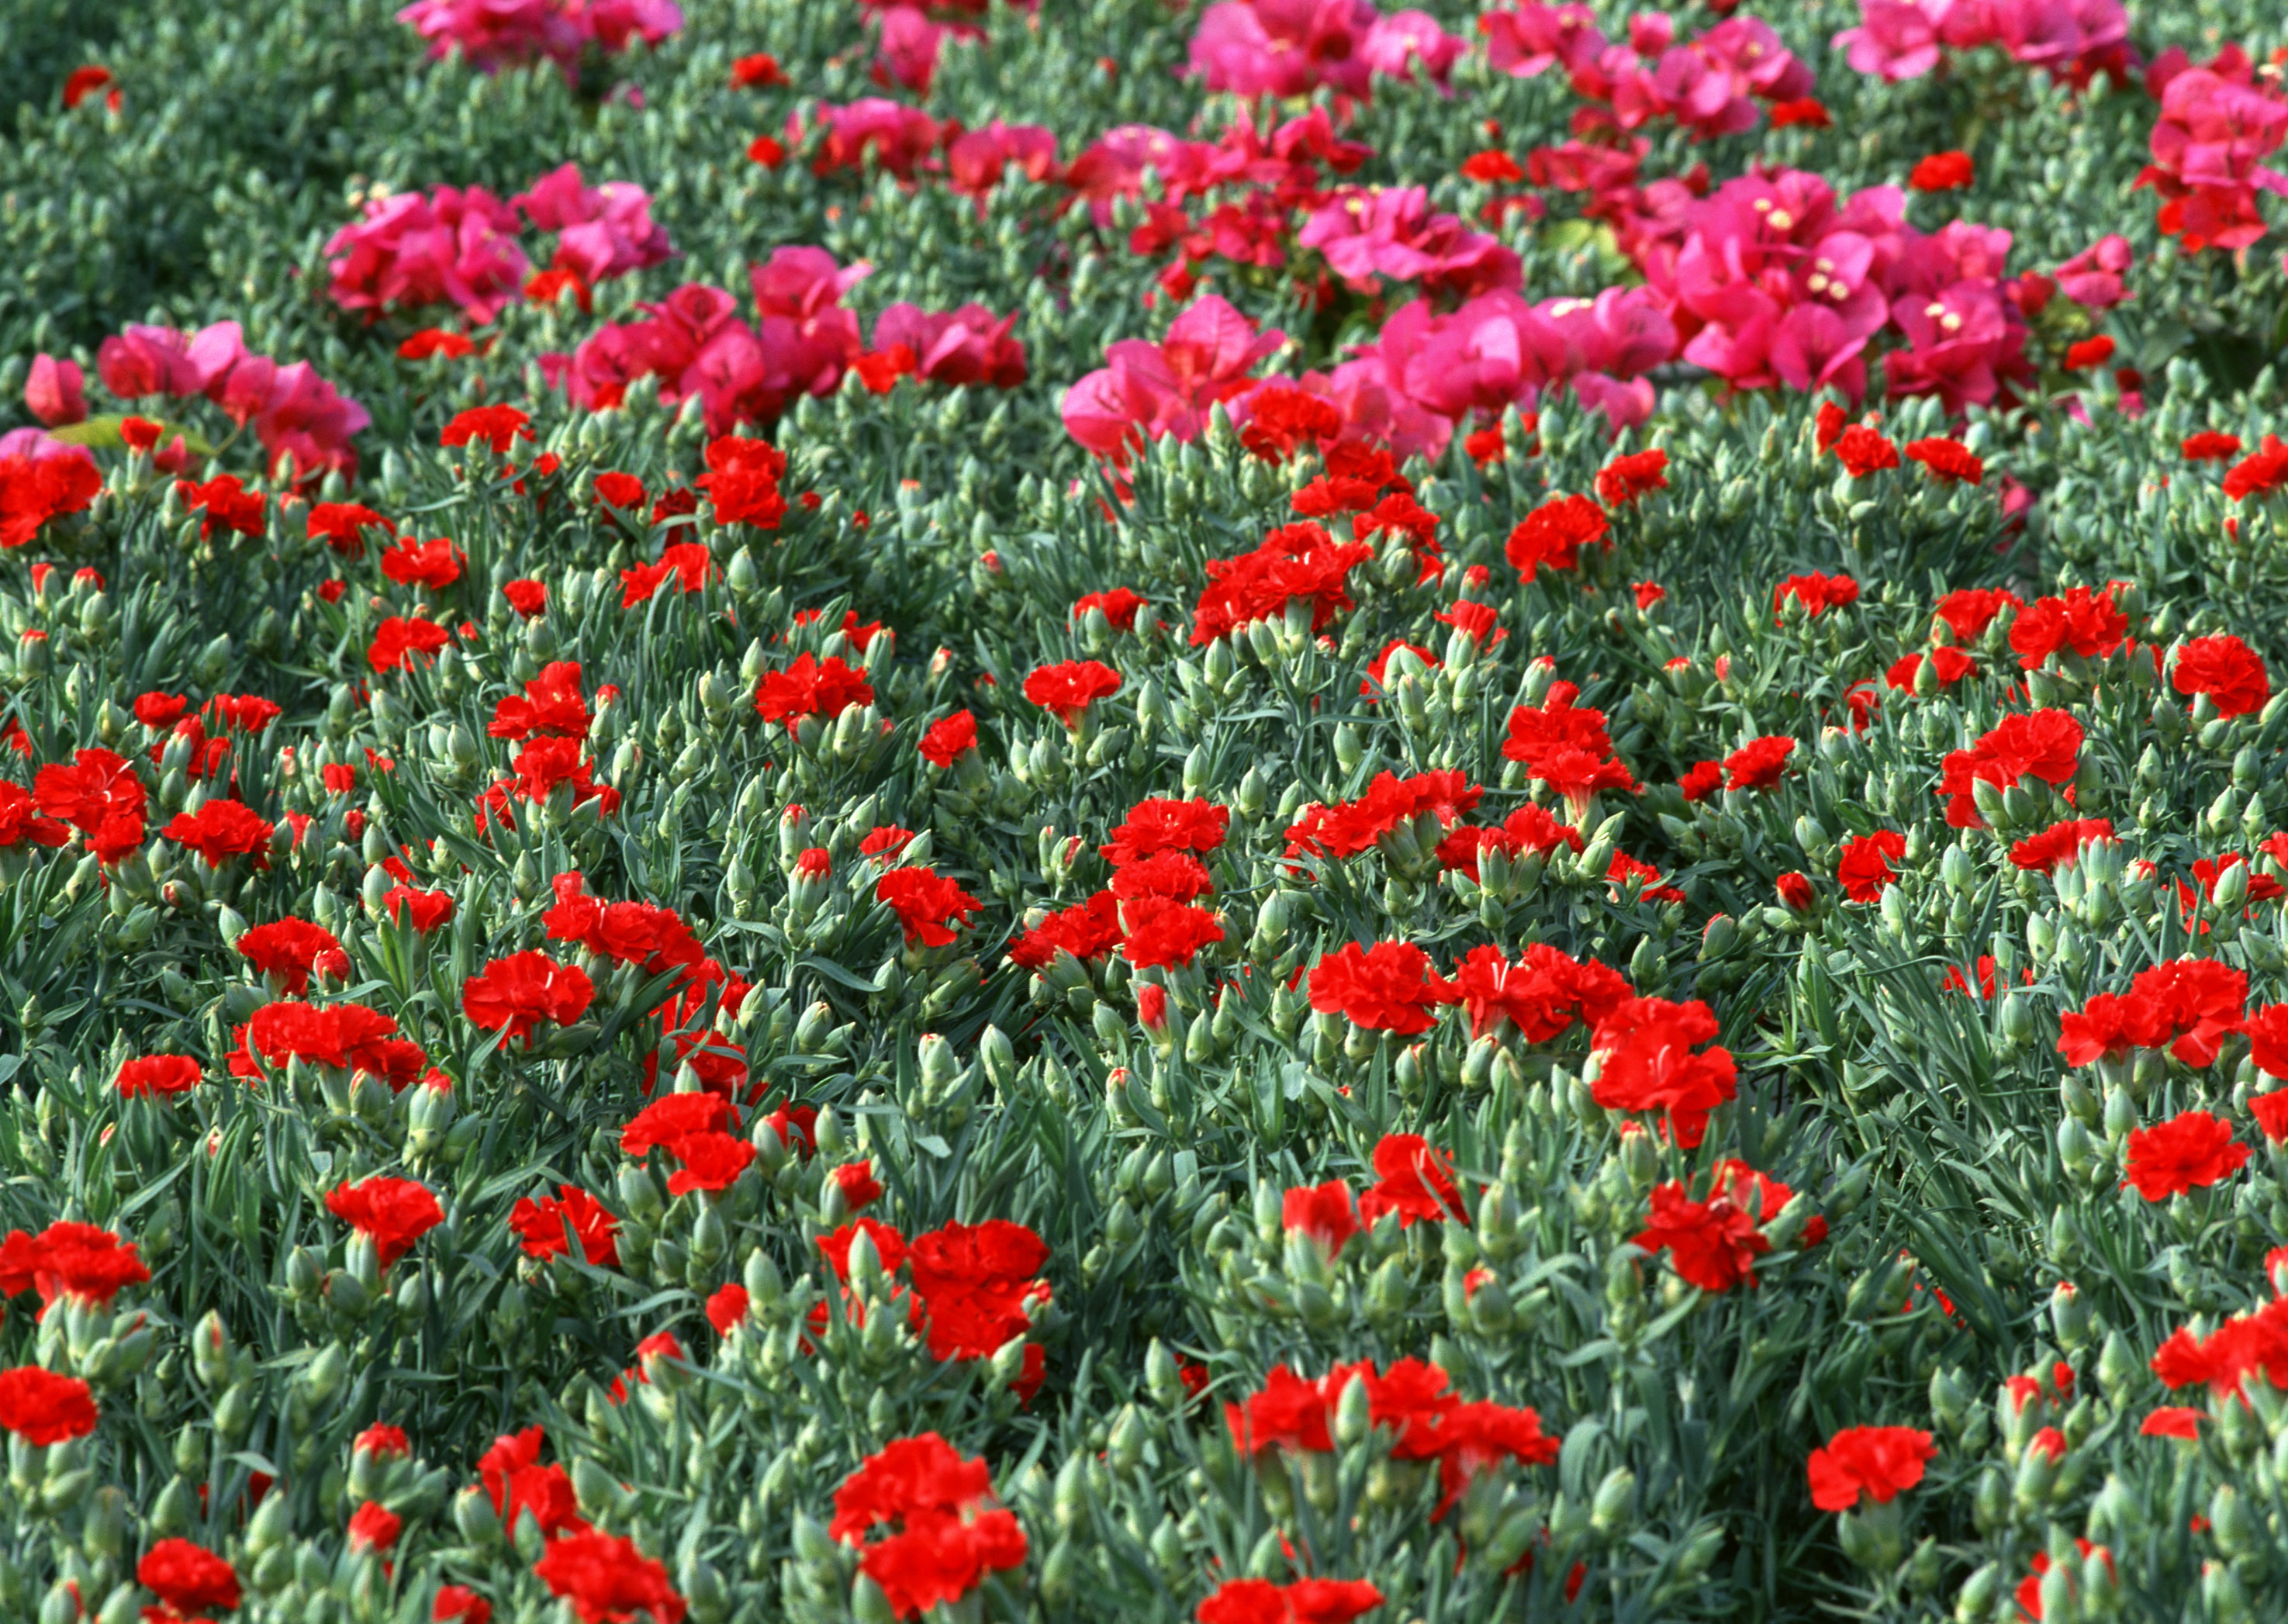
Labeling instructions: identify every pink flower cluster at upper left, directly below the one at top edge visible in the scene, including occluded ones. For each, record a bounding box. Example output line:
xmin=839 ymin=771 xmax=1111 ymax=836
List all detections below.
xmin=325 ymin=164 xmax=675 ymax=325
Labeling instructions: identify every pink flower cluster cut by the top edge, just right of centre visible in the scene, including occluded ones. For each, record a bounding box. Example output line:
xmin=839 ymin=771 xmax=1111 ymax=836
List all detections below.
xmin=1190 ymin=0 xmax=1467 ymax=101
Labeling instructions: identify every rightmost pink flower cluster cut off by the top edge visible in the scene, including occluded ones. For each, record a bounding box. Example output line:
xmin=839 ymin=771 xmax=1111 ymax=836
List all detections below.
xmin=1835 ymin=0 xmax=2132 ymax=87
